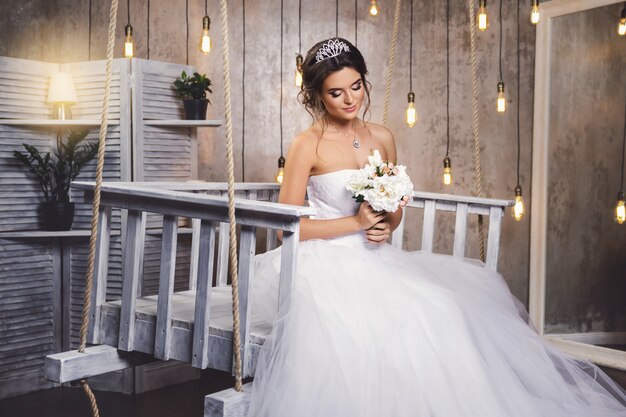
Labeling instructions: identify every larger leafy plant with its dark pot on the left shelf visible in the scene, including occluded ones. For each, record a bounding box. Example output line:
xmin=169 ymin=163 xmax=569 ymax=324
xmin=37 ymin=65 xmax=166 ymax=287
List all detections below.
xmin=13 ymin=129 xmax=98 ymax=231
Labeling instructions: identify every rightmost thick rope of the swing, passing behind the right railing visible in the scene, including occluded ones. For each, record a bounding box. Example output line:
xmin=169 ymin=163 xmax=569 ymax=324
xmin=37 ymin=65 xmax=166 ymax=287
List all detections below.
xmin=468 ymin=0 xmax=485 ymax=262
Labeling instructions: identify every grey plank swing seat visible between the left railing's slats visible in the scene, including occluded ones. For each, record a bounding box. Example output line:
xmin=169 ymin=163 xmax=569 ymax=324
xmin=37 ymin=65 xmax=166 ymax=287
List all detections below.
xmin=101 ymin=286 xmax=272 ymax=371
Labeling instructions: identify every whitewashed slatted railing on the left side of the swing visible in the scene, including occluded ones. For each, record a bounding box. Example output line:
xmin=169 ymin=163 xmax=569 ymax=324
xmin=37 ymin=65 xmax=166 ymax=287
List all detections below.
xmin=74 ymin=183 xmax=313 ymax=375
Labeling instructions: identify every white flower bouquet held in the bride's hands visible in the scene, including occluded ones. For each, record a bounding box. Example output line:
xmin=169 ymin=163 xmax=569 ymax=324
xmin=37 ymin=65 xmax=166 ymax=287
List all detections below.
xmin=346 ymin=150 xmax=413 ymax=213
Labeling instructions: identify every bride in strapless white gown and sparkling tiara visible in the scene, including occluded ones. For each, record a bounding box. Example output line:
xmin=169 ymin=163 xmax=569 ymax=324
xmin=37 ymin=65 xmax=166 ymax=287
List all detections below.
xmin=248 ymin=38 xmax=626 ymax=417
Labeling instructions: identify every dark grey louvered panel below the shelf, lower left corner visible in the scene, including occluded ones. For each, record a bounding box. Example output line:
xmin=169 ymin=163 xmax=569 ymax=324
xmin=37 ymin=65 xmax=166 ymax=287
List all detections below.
xmin=0 ymin=240 xmax=54 ymax=389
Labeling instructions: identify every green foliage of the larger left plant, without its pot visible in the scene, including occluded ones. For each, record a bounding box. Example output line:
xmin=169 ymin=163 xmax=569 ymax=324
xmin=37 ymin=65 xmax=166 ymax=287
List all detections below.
xmin=13 ymin=129 xmax=98 ymax=203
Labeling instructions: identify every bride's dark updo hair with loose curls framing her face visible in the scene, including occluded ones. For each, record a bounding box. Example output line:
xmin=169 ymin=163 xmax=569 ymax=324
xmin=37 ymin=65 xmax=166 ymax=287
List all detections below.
xmin=298 ymin=38 xmax=370 ymax=121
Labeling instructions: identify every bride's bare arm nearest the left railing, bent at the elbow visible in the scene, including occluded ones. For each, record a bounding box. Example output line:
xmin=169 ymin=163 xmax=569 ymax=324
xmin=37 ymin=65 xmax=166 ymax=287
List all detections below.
xmin=278 ymin=132 xmax=382 ymax=240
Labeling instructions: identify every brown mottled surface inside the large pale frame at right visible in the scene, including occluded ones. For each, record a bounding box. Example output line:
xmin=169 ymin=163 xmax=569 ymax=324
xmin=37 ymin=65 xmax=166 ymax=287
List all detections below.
xmin=546 ymin=4 xmax=626 ymax=331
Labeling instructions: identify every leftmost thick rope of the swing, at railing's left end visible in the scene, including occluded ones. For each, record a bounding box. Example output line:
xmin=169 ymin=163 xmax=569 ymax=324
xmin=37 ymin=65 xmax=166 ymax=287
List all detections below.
xmin=78 ymin=0 xmax=118 ymax=417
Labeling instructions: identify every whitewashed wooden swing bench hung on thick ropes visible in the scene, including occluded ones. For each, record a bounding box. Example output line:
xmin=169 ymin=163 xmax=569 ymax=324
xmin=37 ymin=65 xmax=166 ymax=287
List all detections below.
xmin=45 ymin=0 xmax=513 ymax=416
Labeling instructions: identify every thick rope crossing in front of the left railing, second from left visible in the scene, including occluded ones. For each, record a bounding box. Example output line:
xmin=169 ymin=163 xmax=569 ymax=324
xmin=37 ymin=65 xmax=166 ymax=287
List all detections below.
xmin=220 ymin=0 xmax=243 ymax=391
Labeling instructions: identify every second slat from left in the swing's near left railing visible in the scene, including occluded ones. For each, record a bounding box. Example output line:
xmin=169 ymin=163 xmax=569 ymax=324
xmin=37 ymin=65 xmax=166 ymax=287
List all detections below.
xmin=118 ymin=210 xmax=146 ymax=351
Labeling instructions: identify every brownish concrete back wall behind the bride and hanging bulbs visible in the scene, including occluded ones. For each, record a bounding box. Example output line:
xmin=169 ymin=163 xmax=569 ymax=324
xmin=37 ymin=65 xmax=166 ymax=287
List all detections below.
xmin=0 ymin=0 xmax=620 ymax=332
